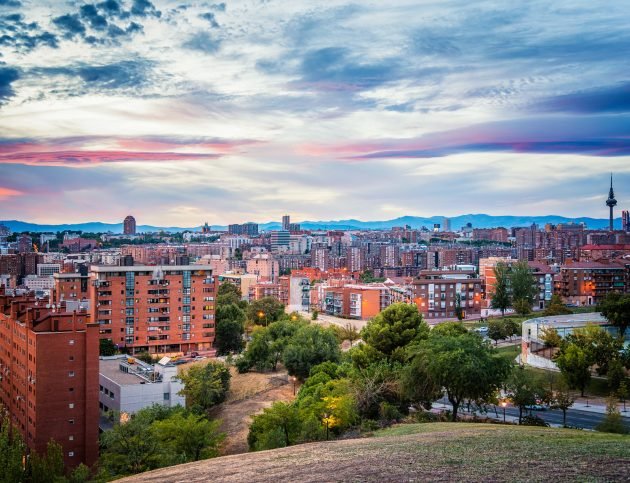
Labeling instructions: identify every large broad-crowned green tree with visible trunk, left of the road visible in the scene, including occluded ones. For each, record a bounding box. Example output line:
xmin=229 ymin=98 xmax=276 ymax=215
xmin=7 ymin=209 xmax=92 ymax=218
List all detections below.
xmin=404 ymin=333 xmax=511 ymax=421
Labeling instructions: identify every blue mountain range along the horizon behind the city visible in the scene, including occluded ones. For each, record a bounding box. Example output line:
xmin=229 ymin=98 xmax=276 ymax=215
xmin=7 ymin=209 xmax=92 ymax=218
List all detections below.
xmin=0 ymin=214 xmax=621 ymax=233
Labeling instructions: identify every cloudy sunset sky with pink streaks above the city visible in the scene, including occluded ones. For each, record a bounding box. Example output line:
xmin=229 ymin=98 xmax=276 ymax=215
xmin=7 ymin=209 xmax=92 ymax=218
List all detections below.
xmin=0 ymin=0 xmax=630 ymax=226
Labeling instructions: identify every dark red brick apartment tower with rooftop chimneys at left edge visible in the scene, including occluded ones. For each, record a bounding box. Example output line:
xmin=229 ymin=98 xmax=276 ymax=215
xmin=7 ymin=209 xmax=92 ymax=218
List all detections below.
xmin=0 ymin=292 xmax=99 ymax=467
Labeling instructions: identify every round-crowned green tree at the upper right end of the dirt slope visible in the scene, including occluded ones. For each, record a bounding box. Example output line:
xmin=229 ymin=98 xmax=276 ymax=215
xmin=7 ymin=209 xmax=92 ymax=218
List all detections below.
xmin=283 ymin=325 xmax=340 ymax=380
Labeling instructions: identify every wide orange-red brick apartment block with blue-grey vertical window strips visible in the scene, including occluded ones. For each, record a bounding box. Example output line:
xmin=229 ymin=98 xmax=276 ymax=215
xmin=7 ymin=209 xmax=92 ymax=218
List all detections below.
xmin=90 ymin=265 xmax=218 ymax=353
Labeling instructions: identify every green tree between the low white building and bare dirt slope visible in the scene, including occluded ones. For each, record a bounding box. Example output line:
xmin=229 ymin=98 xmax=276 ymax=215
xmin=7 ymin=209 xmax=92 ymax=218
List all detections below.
xmin=178 ymin=361 xmax=230 ymax=411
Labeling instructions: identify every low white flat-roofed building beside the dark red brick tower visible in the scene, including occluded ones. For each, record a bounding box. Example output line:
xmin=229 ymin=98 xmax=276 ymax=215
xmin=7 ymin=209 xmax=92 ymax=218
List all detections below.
xmin=98 ymin=355 xmax=186 ymax=414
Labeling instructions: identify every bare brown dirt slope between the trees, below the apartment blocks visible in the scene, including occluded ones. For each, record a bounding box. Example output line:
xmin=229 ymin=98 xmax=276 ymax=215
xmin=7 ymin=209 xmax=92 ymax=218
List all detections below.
xmin=210 ymin=371 xmax=294 ymax=455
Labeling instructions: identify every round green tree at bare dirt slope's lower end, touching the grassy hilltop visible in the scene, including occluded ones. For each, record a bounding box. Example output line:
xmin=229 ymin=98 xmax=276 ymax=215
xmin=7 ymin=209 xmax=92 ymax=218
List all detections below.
xmin=247 ymin=401 xmax=301 ymax=451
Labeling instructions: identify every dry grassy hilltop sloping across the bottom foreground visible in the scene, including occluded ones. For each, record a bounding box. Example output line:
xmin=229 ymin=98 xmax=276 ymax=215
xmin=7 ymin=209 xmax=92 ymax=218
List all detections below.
xmin=121 ymin=423 xmax=630 ymax=483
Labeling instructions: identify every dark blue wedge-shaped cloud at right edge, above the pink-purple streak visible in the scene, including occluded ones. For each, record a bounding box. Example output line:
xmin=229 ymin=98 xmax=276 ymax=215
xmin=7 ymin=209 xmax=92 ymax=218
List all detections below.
xmin=535 ymin=82 xmax=630 ymax=114
